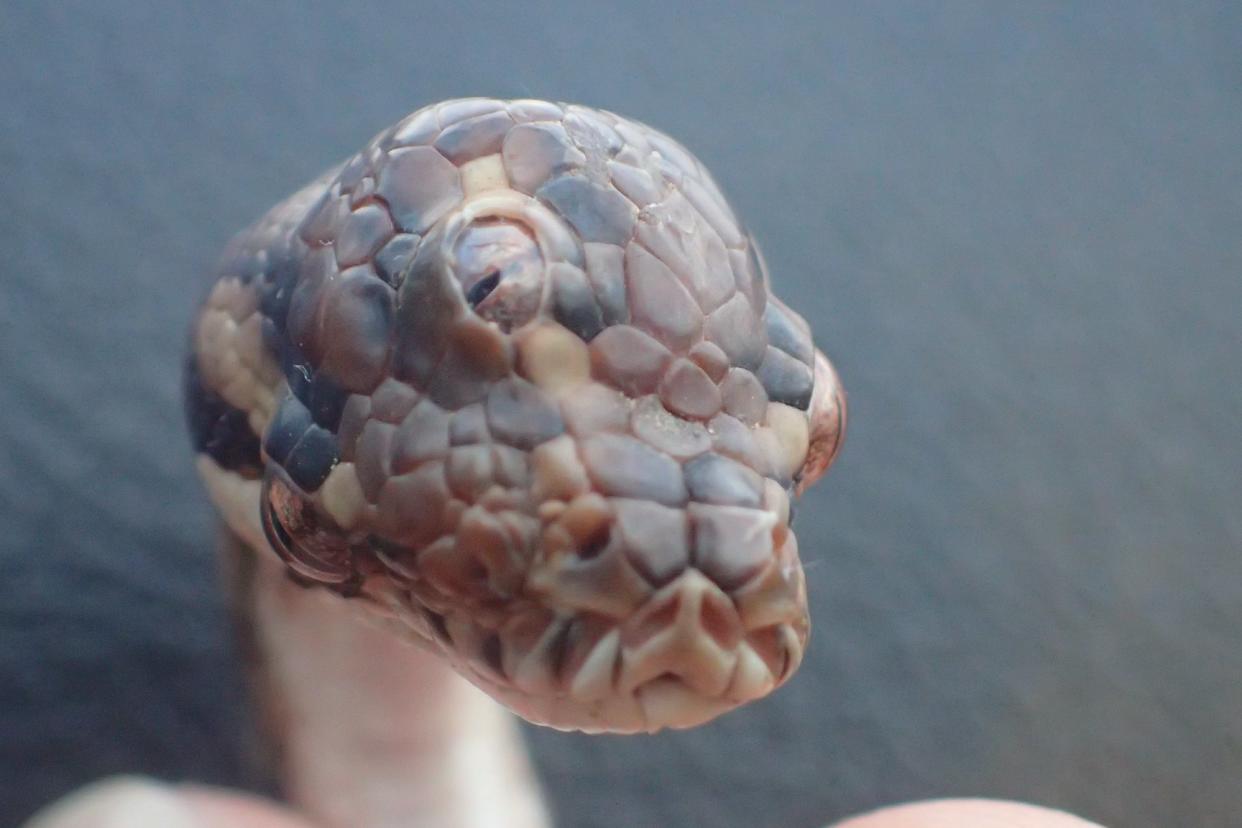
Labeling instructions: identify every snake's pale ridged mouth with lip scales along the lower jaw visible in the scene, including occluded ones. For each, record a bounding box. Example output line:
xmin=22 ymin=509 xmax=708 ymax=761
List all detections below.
xmin=392 ymin=569 xmax=809 ymax=732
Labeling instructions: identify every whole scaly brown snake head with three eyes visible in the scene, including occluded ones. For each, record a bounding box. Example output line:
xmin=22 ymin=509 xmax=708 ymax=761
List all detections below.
xmin=184 ymin=98 xmax=846 ymax=819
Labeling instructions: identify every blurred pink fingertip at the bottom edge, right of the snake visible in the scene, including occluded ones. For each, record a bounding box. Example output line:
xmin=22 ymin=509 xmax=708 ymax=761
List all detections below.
xmin=830 ymin=799 xmax=1100 ymax=828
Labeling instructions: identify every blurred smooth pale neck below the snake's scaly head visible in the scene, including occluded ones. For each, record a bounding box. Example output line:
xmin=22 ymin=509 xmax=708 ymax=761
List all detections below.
xmin=222 ymin=531 xmax=549 ymax=828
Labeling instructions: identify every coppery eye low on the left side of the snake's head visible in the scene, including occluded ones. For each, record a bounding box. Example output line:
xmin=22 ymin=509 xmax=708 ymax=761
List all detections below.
xmin=260 ymin=464 xmax=355 ymax=587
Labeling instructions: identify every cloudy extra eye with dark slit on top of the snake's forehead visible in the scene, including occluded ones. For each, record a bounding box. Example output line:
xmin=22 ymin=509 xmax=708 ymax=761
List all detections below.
xmin=452 ymin=218 xmax=544 ymax=333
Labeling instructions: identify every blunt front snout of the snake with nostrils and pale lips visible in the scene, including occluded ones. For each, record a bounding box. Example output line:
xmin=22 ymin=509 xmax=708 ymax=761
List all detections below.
xmin=504 ymin=479 xmax=809 ymax=730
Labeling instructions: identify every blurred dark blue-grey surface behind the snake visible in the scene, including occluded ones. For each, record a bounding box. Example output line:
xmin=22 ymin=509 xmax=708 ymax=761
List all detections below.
xmin=0 ymin=0 xmax=1242 ymax=827
